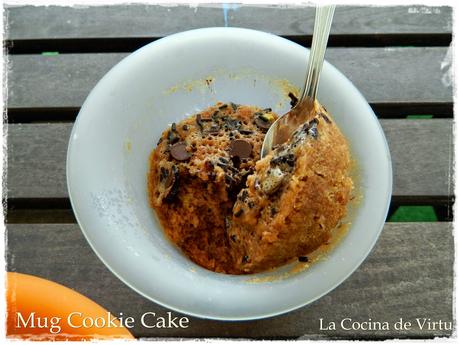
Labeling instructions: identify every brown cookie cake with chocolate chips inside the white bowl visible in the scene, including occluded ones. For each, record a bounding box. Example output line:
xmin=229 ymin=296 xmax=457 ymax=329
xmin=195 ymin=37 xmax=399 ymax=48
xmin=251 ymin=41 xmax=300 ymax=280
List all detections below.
xmin=148 ymin=103 xmax=353 ymax=274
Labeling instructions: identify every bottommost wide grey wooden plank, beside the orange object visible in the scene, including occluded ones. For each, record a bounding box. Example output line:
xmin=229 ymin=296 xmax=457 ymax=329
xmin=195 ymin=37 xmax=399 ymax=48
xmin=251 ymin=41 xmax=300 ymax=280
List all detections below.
xmin=7 ymin=223 xmax=454 ymax=339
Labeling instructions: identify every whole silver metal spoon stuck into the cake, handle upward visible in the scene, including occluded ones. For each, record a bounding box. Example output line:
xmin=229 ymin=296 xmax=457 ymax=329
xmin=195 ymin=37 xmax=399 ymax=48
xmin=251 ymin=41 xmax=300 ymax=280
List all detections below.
xmin=261 ymin=5 xmax=335 ymax=158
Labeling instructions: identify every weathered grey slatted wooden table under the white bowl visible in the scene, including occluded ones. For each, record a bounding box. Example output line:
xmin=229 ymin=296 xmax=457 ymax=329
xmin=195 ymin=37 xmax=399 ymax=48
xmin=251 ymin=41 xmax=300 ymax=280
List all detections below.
xmin=6 ymin=5 xmax=454 ymax=339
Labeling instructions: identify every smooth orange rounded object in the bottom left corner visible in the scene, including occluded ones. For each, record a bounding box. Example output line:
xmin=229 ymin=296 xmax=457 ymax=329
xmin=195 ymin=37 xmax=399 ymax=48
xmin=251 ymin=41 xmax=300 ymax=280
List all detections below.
xmin=6 ymin=272 xmax=134 ymax=340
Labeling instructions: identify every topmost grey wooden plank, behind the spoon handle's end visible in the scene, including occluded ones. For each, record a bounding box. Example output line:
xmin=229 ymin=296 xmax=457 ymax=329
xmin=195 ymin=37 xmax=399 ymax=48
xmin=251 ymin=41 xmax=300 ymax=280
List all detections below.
xmin=7 ymin=4 xmax=452 ymax=40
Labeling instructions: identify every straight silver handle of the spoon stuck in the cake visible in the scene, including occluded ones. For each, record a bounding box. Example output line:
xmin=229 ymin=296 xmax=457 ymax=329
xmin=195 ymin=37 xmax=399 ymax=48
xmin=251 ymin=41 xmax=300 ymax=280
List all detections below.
xmin=301 ymin=5 xmax=335 ymax=100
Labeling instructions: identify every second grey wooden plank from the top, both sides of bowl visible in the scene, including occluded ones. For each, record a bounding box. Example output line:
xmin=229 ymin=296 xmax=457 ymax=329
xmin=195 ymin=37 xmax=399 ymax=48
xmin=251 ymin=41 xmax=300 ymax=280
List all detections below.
xmin=8 ymin=47 xmax=452 ymax=113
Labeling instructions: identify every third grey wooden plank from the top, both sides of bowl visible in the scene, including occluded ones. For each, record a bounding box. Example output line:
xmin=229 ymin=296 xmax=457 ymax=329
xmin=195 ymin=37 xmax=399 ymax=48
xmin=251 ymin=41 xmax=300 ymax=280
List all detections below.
xmin=7 ymin=119 xmax=453 ymax=203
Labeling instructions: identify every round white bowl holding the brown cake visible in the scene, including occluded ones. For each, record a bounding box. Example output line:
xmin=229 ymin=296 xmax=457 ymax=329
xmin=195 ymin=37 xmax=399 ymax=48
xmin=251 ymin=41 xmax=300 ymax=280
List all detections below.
xmin=67 ymin=28 xmax=392 ymax=320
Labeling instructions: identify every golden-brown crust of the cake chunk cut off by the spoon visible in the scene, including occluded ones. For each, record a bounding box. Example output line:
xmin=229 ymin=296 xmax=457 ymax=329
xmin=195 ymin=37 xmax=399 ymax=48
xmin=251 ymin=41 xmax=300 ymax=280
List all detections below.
xmin=229 ymin=102 xmax=353 ymax=273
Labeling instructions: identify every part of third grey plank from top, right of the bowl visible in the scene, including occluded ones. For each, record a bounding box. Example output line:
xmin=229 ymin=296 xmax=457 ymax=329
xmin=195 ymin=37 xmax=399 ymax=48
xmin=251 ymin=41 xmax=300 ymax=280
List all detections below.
xmin=381 ymin=120 xmax=454 ymax=203
